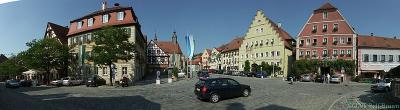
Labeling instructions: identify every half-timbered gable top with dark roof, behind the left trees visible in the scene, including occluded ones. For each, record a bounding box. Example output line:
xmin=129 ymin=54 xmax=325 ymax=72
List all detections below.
xmin=44 ymin=22 xmax=68 ymax=45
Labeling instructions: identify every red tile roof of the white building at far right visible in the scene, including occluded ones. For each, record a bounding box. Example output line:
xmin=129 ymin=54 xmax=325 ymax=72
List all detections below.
xmin=358 ymin=35 xmax=400 ymax=49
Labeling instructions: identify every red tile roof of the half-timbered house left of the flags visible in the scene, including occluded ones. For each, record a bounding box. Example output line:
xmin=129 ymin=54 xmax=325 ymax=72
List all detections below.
xmin=154 ymin=41 xmax=182 ymax=54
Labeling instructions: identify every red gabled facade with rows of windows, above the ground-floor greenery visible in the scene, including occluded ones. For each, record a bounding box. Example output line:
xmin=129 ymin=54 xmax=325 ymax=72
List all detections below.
xmin=296 ymin=3 xmax=357 ymax=74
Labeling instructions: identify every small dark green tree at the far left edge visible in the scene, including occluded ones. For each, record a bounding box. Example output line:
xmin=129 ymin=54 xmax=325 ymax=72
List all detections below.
xmin=0 ymin=56 xmax=27 ymax=79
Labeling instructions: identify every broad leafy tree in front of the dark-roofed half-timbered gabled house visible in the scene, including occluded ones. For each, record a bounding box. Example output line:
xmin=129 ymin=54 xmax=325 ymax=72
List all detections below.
xmin=20 ymin=38 xmax=69 ymax=83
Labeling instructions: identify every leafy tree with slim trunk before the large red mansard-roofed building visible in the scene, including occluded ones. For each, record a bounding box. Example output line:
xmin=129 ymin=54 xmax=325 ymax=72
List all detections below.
xmin=89 ymin=26 xmax=135 ymax=86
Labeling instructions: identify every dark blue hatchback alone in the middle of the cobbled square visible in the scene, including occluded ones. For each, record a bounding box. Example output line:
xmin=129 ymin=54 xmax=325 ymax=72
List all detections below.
xmin=194 ymin=78 xmax=251 ymax=103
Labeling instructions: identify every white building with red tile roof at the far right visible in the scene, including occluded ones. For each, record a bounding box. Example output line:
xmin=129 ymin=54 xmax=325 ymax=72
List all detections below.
xmin=357 ymin=35 xmax=400 ymax=78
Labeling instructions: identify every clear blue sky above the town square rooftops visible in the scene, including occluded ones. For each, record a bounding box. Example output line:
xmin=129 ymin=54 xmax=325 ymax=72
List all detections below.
xmin=0 ymin=0 xmax=400 ymax=56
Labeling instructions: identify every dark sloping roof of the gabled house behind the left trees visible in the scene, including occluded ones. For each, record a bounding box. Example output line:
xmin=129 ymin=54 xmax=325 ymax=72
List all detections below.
xmin=45 ymin=22 xmax=68 ymax=44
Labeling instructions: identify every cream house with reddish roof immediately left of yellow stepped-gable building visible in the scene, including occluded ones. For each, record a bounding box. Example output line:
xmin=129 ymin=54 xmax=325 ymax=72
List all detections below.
xmin=220 ymin=37 xmax=243 ymax=71
